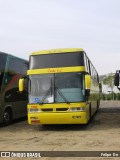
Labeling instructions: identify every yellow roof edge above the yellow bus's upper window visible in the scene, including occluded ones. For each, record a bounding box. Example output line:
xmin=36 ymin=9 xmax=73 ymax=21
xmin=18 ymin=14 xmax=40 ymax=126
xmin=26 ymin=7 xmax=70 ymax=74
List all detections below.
xmin=32 ymin=48 xmax=83 ymax=55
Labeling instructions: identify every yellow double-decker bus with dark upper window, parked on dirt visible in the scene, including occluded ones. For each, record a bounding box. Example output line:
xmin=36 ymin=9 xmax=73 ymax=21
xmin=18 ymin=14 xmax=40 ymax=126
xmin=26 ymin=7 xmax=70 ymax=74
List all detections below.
xmin=19 ymin=48 xmax=100 ymax=125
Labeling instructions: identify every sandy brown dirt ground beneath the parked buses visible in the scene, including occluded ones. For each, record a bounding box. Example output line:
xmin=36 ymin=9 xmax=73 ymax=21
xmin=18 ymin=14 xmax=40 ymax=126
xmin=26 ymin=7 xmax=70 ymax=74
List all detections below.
xmin=0 ymin=101 xmax=120 ymax=160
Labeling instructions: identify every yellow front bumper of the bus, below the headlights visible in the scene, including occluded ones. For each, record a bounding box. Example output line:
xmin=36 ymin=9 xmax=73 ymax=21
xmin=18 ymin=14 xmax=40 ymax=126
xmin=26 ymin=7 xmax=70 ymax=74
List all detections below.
xmin=28 ymin=112 xmax=89 ymax=125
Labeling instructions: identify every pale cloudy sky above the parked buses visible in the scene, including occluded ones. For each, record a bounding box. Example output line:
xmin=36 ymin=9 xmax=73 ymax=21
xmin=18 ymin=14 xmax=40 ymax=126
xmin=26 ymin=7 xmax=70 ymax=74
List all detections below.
xmin=0 ymin=0 xmax=120 ymax=75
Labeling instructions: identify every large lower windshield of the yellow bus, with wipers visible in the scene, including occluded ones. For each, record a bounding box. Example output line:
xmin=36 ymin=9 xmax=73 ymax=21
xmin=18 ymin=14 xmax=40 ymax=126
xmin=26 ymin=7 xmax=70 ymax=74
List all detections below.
xmin=29 ymin=72 xmax=85 ymax=104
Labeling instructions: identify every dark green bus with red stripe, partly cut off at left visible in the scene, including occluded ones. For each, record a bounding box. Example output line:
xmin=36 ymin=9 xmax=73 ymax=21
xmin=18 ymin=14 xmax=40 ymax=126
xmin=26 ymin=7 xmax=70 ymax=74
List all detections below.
xmin=0 ymin=52 xmax=28 ymax=125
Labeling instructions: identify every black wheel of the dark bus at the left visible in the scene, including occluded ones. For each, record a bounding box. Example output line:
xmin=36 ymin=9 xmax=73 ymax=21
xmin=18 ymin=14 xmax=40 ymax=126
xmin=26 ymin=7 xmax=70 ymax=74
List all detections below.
xmin=3 ymin=109 xmax=12 ymax=126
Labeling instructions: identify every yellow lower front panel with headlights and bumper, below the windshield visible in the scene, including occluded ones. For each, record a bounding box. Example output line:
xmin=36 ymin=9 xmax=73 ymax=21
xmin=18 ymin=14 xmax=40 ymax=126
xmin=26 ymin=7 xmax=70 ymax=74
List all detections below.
xmin=27 ymin=102 xmax=90 ymax=124
